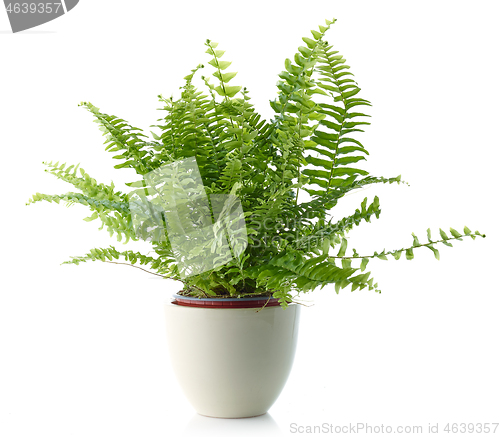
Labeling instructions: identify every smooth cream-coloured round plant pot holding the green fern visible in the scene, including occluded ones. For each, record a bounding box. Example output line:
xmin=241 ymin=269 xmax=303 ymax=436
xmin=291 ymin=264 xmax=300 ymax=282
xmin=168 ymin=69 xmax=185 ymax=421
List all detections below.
xmin=165 ymin=298 xmax=300 ymax=418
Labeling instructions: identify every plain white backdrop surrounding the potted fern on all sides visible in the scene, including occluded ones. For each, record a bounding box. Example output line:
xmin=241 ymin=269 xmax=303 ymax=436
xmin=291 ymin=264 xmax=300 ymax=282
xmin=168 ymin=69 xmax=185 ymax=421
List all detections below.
xmin=0 ymin=0 xmax=500 ymax=437
